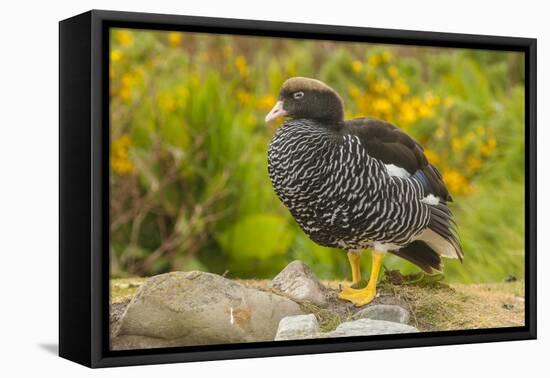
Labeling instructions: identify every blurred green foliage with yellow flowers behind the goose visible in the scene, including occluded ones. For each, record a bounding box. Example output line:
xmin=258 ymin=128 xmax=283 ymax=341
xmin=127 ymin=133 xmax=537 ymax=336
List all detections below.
xmin=110 ymin=29 xmax=524 ymax=282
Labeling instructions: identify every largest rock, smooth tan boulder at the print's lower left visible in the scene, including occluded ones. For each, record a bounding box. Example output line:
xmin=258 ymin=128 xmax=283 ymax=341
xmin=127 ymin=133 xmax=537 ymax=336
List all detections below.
xmin=112 ymin=272 xmax=303 ymax=349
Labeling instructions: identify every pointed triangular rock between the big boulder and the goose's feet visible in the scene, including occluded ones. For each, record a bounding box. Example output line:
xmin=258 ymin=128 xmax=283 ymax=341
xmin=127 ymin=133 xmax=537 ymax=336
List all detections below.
xmin=270 ymin=260 xmax=327 ymax=306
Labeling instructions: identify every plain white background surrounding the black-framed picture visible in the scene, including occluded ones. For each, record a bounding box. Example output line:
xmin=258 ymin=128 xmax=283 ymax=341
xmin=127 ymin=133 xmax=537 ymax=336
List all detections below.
xmin=0 ymin=0 xmax=550 ymax=377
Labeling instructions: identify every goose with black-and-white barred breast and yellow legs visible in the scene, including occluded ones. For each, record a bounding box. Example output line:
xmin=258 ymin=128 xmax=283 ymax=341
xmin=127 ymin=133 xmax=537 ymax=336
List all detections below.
xmin=265 ymin=77 xmax=463 ymax=306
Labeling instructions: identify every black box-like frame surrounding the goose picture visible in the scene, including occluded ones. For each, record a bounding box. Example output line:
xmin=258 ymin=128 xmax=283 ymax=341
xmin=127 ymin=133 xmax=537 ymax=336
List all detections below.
xmin=59 ymin=10 xmax=537 ymax=367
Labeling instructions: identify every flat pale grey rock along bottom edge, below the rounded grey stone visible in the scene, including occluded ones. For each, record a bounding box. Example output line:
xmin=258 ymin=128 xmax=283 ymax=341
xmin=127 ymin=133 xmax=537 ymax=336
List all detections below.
xmin=326 ymin=319 xmax=418 ymax=337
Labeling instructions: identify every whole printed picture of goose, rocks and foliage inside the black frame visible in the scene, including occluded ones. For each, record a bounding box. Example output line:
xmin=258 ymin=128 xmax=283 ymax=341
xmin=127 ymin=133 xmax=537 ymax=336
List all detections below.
xmin=109 ymin=28 xmax=525 ymax=350
